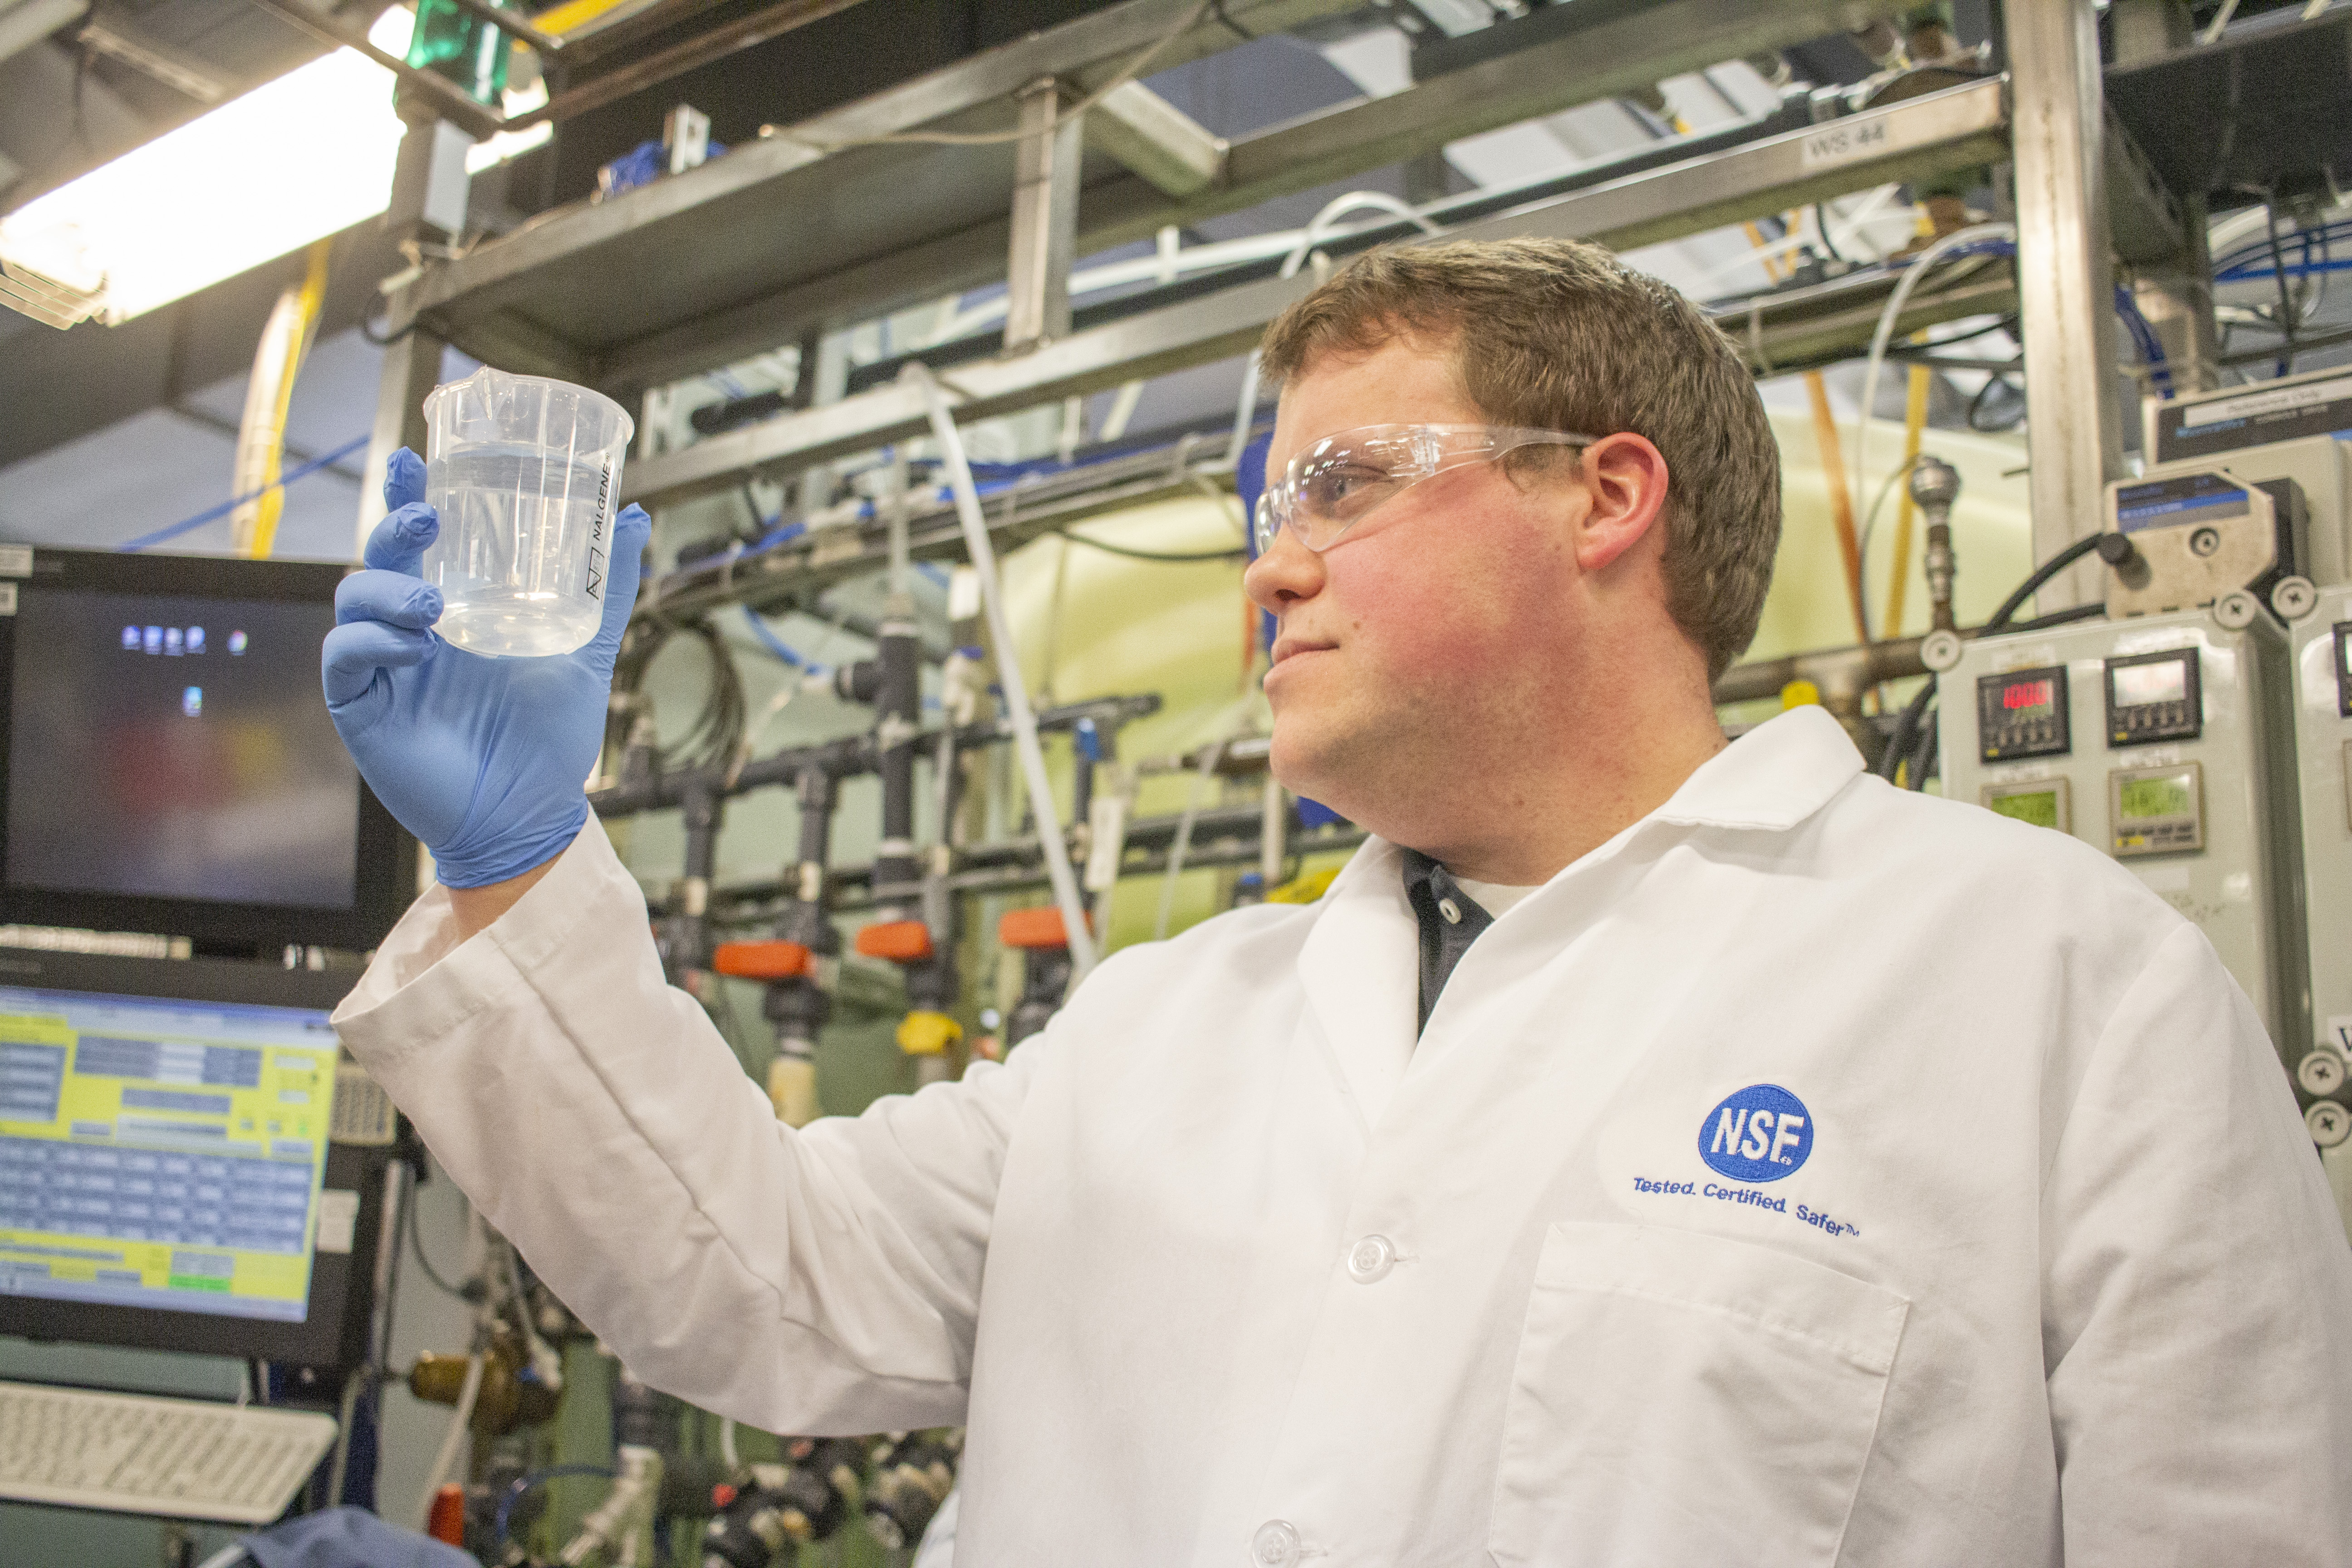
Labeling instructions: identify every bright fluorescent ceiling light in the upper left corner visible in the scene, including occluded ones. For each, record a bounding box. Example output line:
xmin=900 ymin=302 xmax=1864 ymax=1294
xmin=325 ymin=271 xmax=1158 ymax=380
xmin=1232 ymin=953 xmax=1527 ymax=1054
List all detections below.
xmin=0 ymin=7 xmax=548 ymax=327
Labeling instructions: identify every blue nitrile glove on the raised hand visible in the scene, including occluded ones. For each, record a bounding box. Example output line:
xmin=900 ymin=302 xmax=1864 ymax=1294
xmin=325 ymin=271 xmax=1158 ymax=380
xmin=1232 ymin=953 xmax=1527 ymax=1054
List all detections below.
xmin=322 ymin=446 xmax=654 ymax=889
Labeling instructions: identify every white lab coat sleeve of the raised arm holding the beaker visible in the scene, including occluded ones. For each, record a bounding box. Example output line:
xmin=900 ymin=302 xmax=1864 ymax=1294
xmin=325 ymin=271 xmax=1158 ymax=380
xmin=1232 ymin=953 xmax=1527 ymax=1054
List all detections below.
xmin=336 ymin=823 xmax=1047 ymax=1434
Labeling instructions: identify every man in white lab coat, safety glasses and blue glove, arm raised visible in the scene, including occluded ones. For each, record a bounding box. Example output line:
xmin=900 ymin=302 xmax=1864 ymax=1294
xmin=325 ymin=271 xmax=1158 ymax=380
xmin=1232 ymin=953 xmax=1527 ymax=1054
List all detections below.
xmin=327 ymin=242 xmax=2352 ymax=1568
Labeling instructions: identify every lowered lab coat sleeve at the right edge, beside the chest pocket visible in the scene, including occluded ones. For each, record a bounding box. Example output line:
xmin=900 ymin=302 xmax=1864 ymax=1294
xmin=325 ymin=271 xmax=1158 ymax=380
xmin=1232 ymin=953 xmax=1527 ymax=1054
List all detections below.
xmin=2042 ymin=924 xmax=2352 ymax=1568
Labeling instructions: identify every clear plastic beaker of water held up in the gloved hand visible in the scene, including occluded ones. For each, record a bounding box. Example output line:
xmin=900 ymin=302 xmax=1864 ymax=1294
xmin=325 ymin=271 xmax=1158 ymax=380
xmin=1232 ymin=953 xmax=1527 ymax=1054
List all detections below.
xmin=423 ymin=367 xmax=637 ymax=658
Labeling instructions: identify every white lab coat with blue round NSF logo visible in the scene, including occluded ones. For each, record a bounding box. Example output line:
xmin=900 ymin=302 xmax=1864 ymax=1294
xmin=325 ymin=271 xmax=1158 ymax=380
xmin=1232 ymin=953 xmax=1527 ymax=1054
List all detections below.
xmin=336 ymin=710 xmax=2352 ymax=1568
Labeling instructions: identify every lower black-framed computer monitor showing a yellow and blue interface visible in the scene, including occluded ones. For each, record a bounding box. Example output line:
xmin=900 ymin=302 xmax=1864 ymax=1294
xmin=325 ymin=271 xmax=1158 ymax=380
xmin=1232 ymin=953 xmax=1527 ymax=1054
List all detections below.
xmin=0 ymin=947 xmax=388 ymax=1368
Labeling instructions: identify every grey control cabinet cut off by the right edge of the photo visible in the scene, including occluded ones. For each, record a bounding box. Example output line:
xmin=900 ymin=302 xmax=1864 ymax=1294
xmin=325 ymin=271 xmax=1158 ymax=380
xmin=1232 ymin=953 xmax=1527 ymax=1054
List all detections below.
xmin=2288 ymin=585 xmax=2352 ymax=1230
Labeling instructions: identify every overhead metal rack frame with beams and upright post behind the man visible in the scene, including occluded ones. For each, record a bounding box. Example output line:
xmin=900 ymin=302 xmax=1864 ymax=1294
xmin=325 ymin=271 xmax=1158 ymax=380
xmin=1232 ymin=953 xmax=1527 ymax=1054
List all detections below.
xmin=372 ymin=0 xmax=2197 ymax=649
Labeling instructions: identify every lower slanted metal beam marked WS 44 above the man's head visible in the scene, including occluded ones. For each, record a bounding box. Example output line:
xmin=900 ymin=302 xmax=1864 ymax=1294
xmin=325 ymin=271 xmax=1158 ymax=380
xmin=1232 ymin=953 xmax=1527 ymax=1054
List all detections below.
xmin=623 ymin=82 xmax=2004 ymax=503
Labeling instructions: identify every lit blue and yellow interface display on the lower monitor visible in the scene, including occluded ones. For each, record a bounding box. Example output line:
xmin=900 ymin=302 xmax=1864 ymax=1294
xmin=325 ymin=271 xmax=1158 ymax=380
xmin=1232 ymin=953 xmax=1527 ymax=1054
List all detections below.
xmin=0 ymin=985 xmax=348 ymax=1323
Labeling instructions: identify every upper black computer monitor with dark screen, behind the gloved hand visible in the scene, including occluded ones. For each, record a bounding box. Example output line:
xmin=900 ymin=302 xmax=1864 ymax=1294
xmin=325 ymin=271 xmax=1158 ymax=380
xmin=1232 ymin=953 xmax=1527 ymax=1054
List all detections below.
xmin=0 ymin=548 xmax=416 ymax=955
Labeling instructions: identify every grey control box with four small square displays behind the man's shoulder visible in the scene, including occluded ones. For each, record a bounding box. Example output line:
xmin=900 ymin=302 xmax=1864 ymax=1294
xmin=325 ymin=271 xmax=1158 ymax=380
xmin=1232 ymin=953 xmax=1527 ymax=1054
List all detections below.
xmin=1938 ymin=604 xmax=2305 ymax=1062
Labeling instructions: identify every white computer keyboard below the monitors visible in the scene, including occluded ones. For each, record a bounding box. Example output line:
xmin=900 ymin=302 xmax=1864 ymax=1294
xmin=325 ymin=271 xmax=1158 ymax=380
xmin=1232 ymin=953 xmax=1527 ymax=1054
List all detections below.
xmin=0 ymin=1382 xmax=334 ymax=1526
